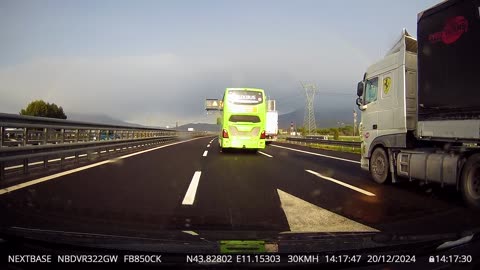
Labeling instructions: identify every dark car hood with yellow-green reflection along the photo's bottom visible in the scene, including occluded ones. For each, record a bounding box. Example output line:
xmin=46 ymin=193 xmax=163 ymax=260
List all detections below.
xmin=0 ymin=227 xmax=478 ymax=253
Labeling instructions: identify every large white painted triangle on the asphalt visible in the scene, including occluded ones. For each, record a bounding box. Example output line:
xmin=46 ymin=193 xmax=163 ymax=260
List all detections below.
xmin=277 ymin=189 xmax=378 ymax=233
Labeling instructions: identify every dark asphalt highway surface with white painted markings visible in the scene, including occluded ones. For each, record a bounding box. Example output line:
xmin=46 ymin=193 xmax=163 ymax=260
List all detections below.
xmin=0 ymin=137 xmax=480 ymax=235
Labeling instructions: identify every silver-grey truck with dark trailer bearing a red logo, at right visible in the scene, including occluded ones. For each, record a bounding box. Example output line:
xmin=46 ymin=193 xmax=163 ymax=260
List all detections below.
xmin=356 ymin=0 xmax=480 ymax=209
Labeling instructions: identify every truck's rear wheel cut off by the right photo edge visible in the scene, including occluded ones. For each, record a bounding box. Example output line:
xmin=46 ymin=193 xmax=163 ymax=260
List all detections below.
xmin=460 ymin=154 xmax=480 ymax=210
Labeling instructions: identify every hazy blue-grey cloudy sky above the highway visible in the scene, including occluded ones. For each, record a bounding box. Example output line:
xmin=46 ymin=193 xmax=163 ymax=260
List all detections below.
xmin=0 ymin=0 xmax=441 ymax=126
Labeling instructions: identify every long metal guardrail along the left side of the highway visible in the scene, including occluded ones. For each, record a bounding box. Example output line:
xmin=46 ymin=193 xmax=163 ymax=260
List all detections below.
xmin=0 ymin=113 xmax=206 ymax=184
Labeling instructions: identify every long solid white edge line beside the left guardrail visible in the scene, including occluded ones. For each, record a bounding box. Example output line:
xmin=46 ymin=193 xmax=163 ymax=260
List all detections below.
xmin=0 ymin=137 xmax=208 ymax=195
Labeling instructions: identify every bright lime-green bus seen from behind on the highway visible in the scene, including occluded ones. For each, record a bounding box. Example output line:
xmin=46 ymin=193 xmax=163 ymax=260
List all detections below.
xmin=218 ymin=88 xmax=267 ymax=150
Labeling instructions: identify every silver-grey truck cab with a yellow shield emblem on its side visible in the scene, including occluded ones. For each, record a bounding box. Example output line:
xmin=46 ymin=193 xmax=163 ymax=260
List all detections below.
xmin=357 ymin=29 xmax=417 ymax=175
